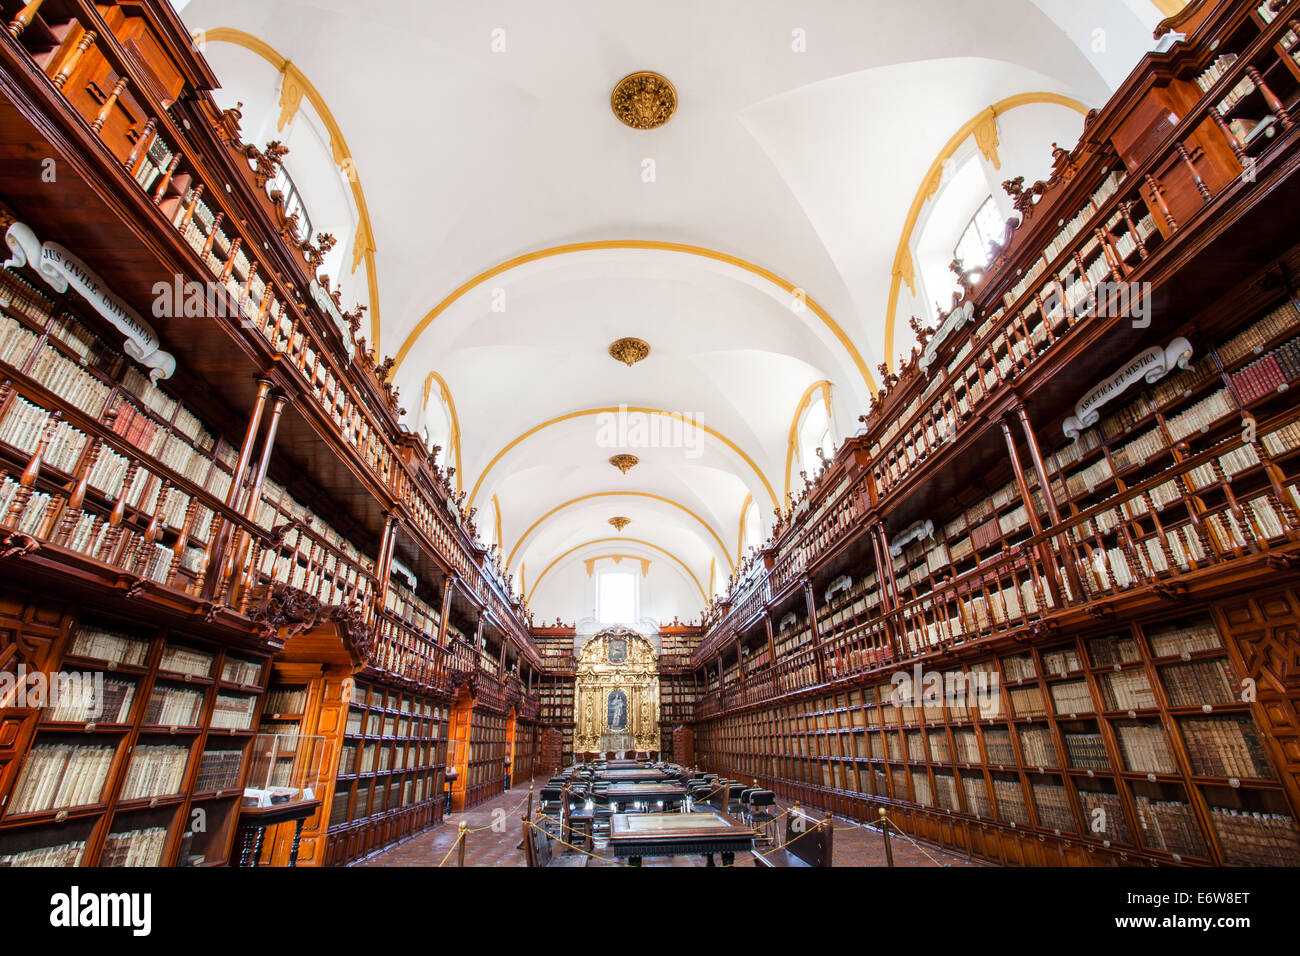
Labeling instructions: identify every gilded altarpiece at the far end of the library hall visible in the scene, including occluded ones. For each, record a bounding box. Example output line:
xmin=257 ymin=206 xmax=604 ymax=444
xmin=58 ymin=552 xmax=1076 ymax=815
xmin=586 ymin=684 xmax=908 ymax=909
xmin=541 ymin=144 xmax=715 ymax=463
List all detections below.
xmin=573 ymin=627 xmax=660 ymax=753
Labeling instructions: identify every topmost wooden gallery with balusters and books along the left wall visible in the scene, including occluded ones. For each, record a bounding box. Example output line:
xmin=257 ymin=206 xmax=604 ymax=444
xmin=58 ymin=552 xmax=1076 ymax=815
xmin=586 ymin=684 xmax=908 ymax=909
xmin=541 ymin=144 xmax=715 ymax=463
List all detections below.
xmin=0 ymin=0 xmax=538 ymax=662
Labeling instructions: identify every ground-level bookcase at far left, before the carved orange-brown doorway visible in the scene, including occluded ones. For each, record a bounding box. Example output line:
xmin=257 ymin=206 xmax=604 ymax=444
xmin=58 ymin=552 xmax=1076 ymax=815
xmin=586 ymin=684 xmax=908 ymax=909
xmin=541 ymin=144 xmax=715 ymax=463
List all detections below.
xmin=0 ymin=613 xmax=267 ymax=866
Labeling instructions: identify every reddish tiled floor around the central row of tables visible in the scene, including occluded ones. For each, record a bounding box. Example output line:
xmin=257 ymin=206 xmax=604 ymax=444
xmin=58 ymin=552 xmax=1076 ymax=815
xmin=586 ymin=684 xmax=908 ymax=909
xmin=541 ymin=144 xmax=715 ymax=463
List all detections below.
xmin=355 ymin=778 xmax=979 ymax=866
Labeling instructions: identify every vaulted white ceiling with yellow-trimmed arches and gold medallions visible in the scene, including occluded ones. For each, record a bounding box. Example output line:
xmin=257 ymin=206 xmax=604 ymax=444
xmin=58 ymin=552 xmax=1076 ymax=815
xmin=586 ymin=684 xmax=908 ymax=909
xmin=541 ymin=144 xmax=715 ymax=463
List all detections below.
xmin=177 ymin=0 xmax=1161 ymax=619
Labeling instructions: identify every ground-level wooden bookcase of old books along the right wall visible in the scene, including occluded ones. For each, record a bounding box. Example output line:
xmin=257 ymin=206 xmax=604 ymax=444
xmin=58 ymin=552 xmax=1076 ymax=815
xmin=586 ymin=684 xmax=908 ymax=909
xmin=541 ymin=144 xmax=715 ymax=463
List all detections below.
xmin=696 ymin=611 xmax=1300 ymax=865
